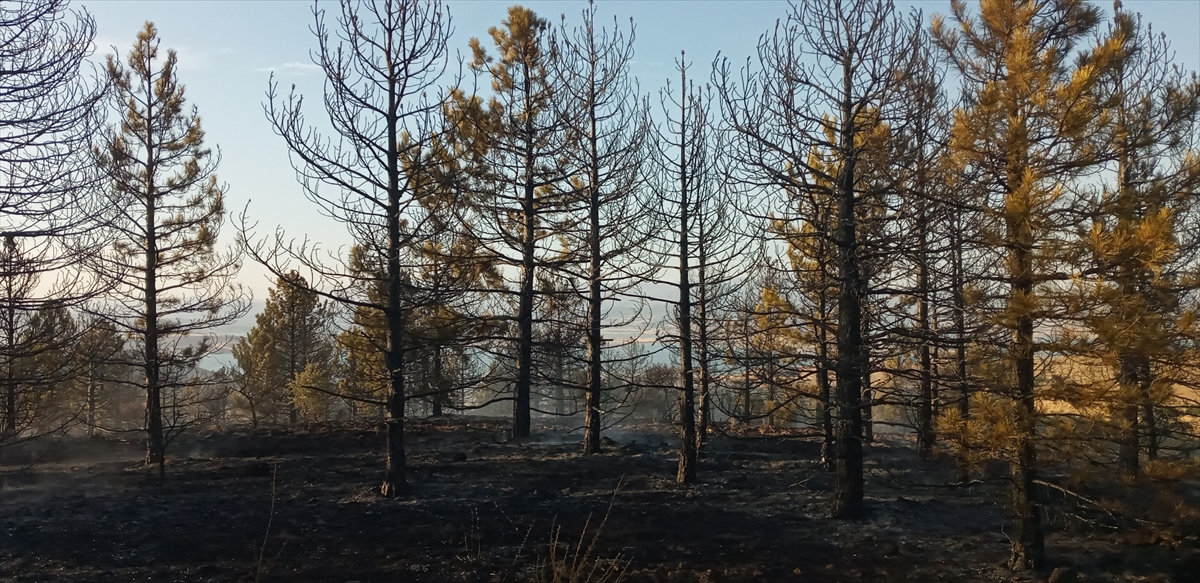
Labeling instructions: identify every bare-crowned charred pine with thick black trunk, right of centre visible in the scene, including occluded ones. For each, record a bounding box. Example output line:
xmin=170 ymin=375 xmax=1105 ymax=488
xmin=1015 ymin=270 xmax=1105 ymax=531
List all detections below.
xmin=714 ymin=0 xmax=917 ymax=518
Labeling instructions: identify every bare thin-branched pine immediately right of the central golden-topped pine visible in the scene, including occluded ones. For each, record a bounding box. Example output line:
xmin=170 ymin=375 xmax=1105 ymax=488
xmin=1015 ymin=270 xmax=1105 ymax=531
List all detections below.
xmin=550 ymin=2 xmax=656 ymax=453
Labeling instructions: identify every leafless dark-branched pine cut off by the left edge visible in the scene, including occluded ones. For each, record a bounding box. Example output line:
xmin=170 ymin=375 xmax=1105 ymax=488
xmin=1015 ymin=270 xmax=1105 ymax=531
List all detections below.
xmin=0 ymin=0 xmax=107 ymax=446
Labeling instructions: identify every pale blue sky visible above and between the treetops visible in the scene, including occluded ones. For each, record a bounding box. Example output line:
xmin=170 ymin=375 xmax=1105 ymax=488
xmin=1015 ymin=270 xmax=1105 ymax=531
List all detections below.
xmin=71 ymin=0 xmax=1200 ymax=335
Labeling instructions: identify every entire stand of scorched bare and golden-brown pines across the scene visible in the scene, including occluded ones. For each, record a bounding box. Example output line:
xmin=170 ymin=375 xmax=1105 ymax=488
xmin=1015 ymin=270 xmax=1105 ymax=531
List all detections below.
xmin=0 ymin=0 xmax=1200 ymax=569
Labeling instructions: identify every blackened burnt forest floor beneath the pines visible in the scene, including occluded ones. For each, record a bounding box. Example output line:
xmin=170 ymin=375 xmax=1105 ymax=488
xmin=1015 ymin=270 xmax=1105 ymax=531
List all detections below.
xmin=0 ymin=419 xmax=1200 ymax=583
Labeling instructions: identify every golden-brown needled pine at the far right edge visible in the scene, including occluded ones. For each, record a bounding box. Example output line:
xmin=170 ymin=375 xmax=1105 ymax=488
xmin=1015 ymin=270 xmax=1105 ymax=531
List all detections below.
xmin=1086 ymin=2 xmax=1200 ymax=476
